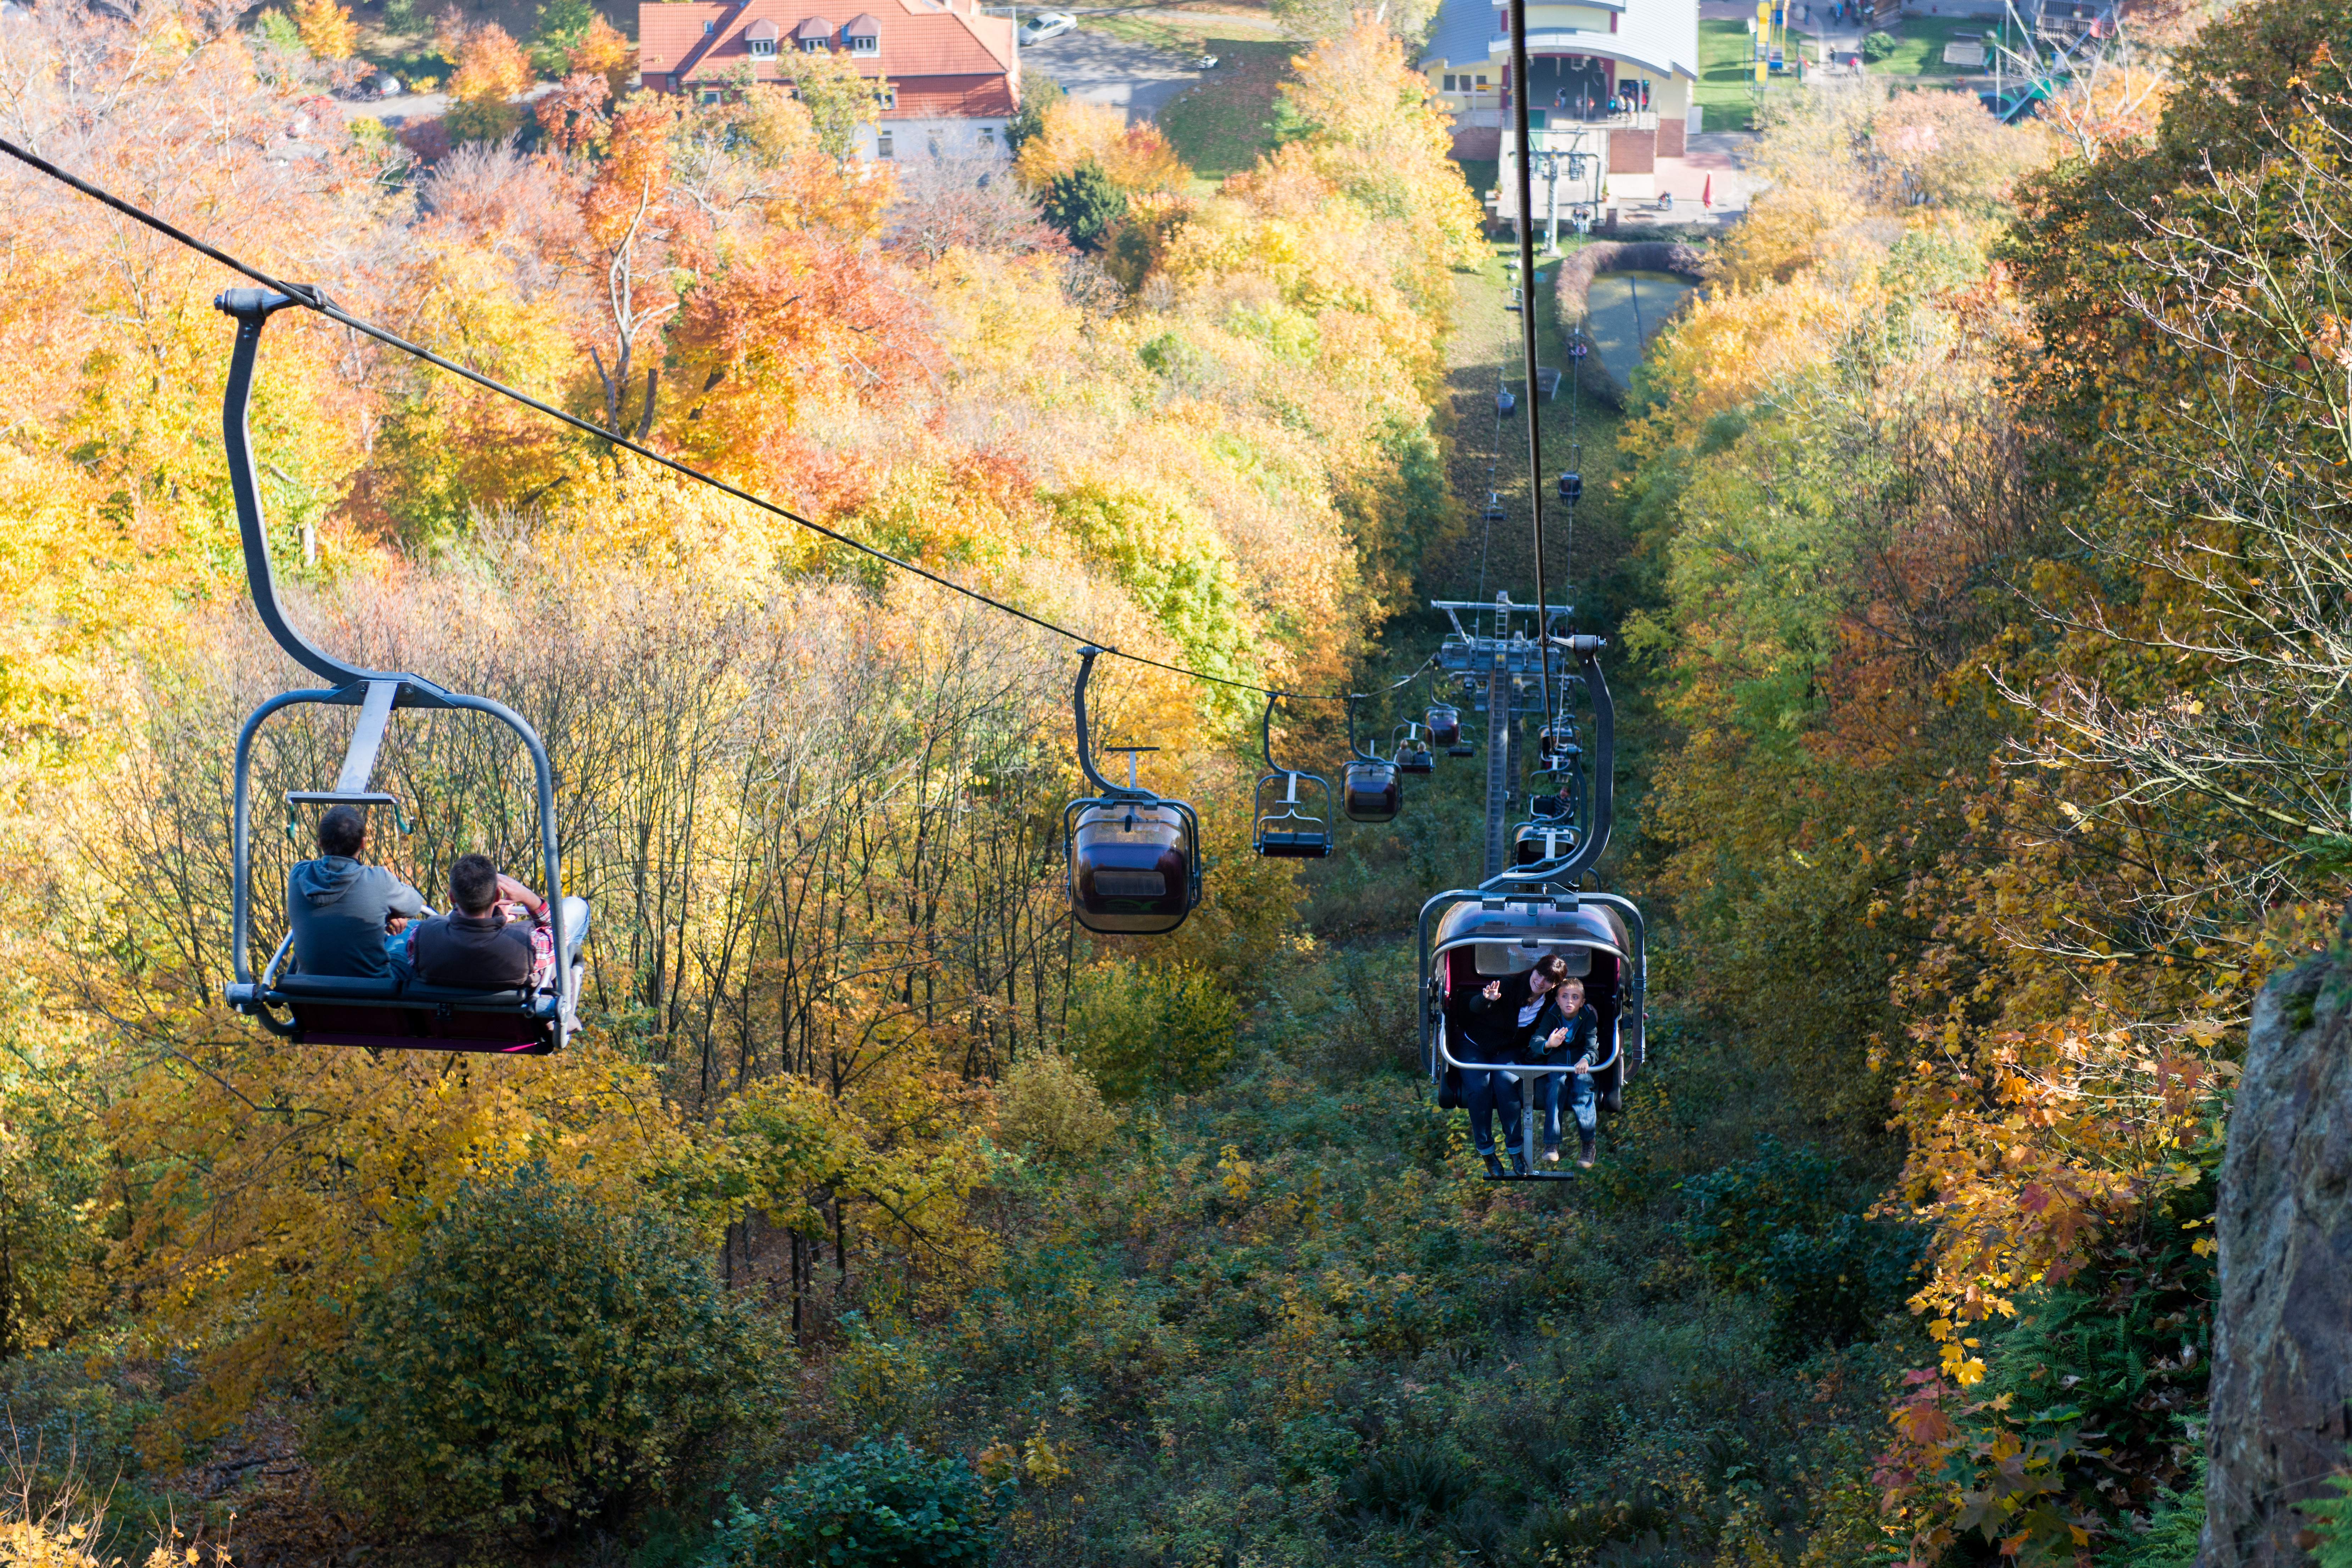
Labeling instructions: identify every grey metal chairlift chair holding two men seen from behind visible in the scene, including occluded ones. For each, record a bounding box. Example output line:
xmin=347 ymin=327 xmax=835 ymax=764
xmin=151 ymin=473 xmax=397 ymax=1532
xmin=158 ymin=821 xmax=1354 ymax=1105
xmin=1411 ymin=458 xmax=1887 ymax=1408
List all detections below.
xmin=214 ymin=289 xmax=578 ymax=1055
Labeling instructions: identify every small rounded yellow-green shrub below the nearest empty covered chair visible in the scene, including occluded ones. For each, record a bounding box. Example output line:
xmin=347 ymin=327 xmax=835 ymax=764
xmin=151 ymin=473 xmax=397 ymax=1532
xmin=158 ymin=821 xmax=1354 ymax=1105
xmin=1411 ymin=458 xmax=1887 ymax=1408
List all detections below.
xmin=1070 ymin=959 xmax=1242 ymax=1100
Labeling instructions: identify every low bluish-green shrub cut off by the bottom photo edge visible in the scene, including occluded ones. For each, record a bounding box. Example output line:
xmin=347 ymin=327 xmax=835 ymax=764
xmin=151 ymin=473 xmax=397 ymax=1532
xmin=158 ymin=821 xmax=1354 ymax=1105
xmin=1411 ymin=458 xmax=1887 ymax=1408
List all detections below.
xmin=703 ymin=1437 xmax=997 ymax=1568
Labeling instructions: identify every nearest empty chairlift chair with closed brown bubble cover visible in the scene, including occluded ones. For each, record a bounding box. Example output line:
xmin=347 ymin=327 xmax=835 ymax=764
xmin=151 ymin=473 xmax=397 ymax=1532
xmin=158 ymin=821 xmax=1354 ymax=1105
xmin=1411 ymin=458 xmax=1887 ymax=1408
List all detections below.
xmin=1061 ymin=646 xmax=1202 ymax=936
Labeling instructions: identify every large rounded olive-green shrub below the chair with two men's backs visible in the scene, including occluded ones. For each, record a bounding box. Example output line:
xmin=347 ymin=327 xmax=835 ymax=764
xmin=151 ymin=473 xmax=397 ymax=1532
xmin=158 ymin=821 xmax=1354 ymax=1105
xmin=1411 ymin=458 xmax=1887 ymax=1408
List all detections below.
xmin=313 ymin=1164 xmax=755 ymax=1535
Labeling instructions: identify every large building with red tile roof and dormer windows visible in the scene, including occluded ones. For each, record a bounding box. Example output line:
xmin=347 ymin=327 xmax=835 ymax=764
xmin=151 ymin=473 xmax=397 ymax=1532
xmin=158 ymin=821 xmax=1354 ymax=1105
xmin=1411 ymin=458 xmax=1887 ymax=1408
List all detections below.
xmin=637 ymin=0 xmax=1021 ymax=157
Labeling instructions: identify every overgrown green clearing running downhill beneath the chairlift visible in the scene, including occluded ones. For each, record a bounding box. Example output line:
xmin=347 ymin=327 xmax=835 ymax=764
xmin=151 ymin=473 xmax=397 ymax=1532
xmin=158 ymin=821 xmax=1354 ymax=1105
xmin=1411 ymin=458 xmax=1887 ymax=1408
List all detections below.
xmin=797 ymin=240 xmax=1922 ymax=1566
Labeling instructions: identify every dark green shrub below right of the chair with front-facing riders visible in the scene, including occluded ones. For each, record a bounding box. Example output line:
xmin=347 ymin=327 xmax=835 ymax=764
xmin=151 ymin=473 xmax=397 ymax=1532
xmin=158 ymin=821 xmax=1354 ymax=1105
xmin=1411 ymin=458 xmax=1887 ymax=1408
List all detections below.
xmin=1682 ymin=1138 xmax=1919 ymax=1349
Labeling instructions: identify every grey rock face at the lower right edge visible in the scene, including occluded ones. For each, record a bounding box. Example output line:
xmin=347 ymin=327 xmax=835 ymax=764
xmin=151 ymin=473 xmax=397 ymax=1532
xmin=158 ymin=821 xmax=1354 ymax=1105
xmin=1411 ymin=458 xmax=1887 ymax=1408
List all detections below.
xmin=2199 ymin=940 xmax=2352 ymax=1568
